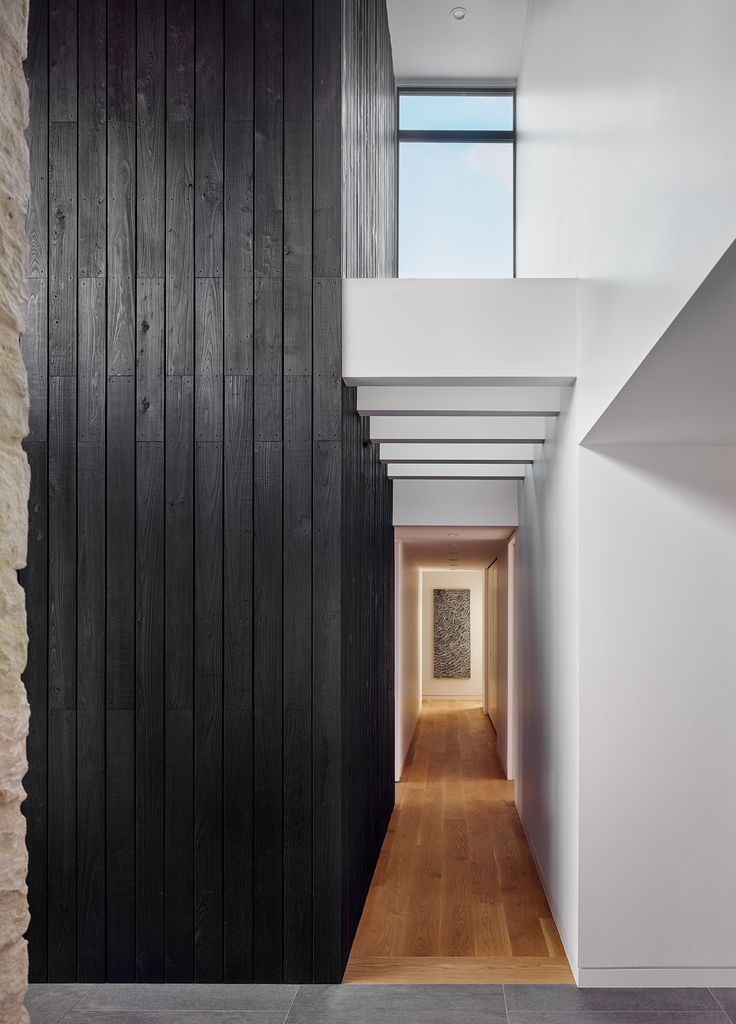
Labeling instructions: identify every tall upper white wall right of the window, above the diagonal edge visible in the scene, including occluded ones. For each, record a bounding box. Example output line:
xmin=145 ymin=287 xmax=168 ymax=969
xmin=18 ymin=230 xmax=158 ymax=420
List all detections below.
xmin=517 ymin=0 xmax=736 ymax=436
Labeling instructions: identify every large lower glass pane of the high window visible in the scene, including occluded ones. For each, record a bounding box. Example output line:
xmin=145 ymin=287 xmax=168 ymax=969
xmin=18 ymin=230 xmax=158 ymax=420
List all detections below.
xmin=399 ymin=142 xmax=514 ymax=278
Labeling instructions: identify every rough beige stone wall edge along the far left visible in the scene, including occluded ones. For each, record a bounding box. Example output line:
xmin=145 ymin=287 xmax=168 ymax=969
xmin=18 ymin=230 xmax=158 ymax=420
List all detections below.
xmin=0 ymin=0 xmax=30 ymax=1024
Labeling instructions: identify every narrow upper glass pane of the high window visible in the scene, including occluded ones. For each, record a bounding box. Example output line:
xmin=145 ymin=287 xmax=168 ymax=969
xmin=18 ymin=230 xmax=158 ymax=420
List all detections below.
xmin=399 ymin=93 xmax=514 ymax=131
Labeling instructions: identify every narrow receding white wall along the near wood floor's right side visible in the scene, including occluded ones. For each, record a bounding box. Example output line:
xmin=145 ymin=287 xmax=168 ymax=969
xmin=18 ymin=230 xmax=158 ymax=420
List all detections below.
xmin=515 ymin=399 xmax=578 ymax=972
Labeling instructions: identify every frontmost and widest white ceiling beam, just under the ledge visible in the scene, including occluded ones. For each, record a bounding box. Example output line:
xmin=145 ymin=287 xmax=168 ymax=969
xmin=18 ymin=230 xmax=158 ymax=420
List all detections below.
xmin=357 ymin=386 xmax=560 ymax=416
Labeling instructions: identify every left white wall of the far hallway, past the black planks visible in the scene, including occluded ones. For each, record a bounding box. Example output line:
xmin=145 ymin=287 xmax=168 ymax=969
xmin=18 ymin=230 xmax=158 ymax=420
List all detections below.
xmin=394 ymin=541 xmax=422 ymax=780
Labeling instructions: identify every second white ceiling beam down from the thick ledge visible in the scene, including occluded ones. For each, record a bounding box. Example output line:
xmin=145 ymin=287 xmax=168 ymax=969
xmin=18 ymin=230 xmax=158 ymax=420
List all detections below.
xmin=371 ymin=416 xmax=545 ymax=444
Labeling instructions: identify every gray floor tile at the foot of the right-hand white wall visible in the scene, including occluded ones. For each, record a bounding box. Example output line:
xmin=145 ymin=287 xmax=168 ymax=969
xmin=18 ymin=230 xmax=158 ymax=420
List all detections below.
xmin=504 ymin=985 xmax=720 ymax=1011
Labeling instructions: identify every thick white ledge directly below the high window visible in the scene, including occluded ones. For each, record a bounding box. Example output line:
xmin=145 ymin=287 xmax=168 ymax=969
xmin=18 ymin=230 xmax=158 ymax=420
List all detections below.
xmin=343 ymin=278 xmax=577 ymax=387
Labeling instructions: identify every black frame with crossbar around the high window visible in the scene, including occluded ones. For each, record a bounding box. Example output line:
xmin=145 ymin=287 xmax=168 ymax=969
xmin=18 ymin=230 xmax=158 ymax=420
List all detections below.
xmin=396 ymin=86 xmax=516 ymax=278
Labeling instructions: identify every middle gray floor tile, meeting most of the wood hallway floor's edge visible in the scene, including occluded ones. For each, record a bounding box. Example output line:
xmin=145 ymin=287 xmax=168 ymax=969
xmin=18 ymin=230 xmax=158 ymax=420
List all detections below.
xmin=287 ymin=985 xmax=506 ymax=1024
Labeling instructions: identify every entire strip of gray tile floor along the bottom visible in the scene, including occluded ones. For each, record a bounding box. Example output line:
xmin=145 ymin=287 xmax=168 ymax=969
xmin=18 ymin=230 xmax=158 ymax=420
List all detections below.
xmin=26 ymin=984 xmax=736 ymax=1024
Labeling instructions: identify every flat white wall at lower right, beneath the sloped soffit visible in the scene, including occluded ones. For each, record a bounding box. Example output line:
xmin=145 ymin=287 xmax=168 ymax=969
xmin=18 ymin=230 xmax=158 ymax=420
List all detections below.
xmin=580 ymin=444 xmax=736 ymax=984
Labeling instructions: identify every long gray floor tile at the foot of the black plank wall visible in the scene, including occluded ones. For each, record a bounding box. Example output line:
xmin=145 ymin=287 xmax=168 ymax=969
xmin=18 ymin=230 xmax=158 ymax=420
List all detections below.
xmin=77 ymin=985 xmax=297 ymax=1015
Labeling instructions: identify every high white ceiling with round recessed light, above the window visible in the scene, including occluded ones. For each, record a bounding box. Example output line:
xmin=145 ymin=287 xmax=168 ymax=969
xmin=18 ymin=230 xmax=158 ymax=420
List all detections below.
xmin=387 ymin=0 xmax=527 ymax=85
